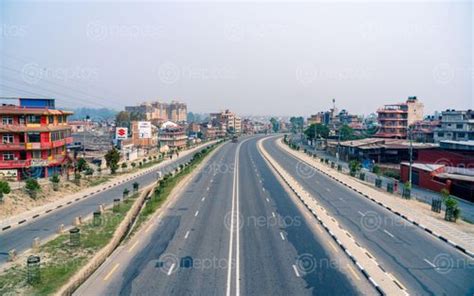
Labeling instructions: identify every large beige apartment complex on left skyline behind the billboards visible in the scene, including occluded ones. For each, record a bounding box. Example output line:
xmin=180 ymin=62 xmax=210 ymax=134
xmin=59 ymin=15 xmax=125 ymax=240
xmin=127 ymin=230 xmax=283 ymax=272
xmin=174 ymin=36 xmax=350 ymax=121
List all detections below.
xmin=125 ymin=101 xmax=188 ymax=122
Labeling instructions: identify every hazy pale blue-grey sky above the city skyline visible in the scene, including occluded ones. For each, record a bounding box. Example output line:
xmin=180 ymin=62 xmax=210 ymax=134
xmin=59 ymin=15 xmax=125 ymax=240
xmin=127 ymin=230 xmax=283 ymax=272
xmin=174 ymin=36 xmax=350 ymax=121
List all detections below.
xmin=0 ymin=1 xmax=474 ymax=116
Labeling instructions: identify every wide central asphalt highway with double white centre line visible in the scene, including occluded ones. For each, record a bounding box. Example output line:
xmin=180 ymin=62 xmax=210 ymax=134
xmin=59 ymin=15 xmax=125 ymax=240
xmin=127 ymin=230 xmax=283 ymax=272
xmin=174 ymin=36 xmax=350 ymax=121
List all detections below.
xmin=75 ymin=137 xmax=375 ymax=295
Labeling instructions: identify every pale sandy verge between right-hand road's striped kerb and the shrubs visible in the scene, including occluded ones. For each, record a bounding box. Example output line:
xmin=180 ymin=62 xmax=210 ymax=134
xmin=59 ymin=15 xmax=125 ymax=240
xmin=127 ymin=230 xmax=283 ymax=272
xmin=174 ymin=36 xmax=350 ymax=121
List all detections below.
xmin=277 ymin=140 xmax=474 ymax=257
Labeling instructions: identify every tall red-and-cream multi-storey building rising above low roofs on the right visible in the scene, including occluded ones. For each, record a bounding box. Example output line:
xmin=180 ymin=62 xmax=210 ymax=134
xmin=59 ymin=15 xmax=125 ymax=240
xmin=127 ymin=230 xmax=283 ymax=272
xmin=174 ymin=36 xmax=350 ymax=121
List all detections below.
xmin=376 ymin=97 xmax=423 ymax=139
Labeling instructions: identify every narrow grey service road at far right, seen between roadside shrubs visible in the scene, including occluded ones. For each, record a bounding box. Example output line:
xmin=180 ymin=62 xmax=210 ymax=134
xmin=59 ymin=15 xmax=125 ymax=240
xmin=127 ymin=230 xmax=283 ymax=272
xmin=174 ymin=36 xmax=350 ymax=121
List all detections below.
xmin=302 ymin=144 xmax=474 ymax=223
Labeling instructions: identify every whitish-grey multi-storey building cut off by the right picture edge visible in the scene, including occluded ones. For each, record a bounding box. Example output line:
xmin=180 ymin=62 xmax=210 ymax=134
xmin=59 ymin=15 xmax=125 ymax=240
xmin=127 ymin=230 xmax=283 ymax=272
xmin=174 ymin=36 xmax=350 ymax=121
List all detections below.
xmin=434 ymin=110 xmax=474 ymax=142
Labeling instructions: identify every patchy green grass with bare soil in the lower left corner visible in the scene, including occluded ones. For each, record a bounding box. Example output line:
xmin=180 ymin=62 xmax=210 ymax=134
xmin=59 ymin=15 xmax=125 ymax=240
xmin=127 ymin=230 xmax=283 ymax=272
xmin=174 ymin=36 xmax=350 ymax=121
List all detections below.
xmin=0 ymin=193 xmax=138 ymax=295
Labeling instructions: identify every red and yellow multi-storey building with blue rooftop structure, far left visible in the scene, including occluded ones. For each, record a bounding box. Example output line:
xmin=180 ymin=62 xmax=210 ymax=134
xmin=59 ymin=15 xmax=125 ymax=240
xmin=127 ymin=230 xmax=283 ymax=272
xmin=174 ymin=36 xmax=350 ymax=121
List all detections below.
xmin=0 ymin=98 xmax=73 ymax=180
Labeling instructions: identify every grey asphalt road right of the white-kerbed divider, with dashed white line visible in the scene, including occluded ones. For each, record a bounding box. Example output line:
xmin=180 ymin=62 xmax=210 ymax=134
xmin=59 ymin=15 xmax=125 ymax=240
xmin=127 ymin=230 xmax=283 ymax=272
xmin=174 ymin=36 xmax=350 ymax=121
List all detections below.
xmin=263 ymin=138 xmax=474 ymax=295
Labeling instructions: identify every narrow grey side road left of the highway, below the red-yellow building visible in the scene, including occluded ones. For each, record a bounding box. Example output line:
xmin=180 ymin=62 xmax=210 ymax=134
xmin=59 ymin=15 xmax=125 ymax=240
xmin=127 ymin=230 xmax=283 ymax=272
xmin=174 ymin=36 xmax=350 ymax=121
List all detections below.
xmin=0 ymin=143 xmax=213 ymax=265
